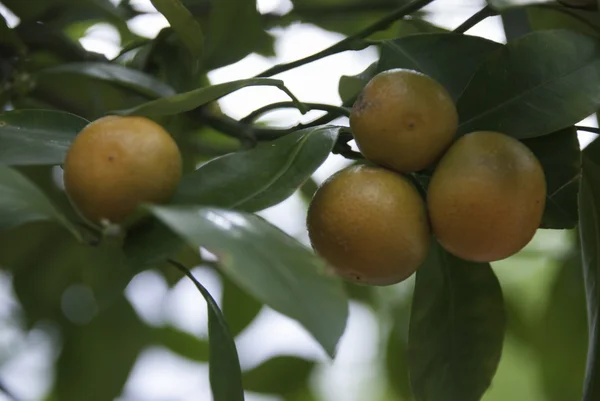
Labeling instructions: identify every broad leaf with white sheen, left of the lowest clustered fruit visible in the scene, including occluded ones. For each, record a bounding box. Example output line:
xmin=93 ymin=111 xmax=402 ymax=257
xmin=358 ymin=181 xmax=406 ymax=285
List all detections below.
xmin=149 ymin=206 xmax=348 ymax=356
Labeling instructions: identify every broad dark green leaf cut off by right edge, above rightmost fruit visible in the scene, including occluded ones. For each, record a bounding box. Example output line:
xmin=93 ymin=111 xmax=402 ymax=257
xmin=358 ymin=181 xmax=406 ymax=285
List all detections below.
xmin=457 ymin=30 xmax=600 ymax=139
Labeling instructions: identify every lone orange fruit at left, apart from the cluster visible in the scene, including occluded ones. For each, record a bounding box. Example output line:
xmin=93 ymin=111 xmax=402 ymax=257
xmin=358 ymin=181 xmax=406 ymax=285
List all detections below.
xmin=63 ymin=116 xmax=182 ymax=223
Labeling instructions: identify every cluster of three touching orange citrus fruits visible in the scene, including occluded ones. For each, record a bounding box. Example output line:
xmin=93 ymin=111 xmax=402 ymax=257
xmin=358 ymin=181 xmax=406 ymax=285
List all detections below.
xmin=307 ymin=69 xmax=546 ymax=285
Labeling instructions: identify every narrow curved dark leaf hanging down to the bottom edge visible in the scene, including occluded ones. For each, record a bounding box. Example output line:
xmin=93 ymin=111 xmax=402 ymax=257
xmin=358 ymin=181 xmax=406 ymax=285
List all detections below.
xmin=175 ymin=263 xmax=244 ymax=401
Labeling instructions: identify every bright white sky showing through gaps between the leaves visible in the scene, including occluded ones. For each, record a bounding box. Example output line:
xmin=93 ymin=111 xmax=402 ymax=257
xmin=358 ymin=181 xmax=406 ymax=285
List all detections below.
xmin=0 ymin=0 xmax=597 ymax=401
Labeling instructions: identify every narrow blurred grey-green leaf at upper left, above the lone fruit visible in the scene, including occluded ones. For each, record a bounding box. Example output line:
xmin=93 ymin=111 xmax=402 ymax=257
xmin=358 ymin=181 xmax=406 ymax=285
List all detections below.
xmin=37 ymin=62 xmax=175 ymax=98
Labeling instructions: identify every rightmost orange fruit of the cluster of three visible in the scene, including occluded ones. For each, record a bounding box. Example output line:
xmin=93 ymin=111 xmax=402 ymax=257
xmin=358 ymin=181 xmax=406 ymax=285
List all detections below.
xmin=427 ymin=131 xmax=546 ymax=262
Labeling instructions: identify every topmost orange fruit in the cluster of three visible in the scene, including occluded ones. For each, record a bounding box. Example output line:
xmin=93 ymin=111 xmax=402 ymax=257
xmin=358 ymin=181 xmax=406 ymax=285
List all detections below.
xmin=350 ymin=69 xmax=458 ymax=172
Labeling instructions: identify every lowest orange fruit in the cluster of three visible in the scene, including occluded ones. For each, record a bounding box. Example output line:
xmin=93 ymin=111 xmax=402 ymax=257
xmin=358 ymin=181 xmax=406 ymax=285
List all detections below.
xmin=307 ymin=165 xmax=430 ymax=285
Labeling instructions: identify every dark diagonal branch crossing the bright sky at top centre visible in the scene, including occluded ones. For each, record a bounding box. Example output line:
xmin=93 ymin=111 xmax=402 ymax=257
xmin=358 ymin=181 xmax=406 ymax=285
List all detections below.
xmin=256 ymin=0 xmax=433 ymax=78
